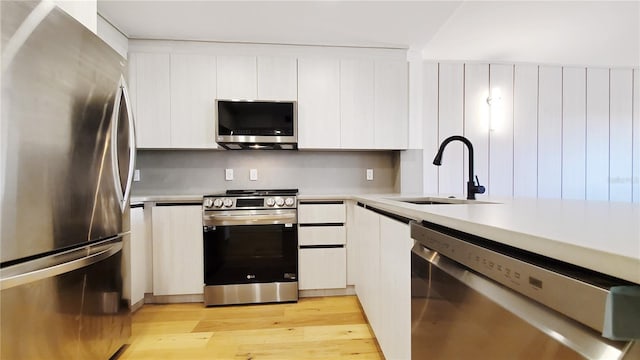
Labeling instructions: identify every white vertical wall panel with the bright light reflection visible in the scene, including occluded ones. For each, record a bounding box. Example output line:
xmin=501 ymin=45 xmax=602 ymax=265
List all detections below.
xmin=487 ymin=65 xmax=513 ymax=197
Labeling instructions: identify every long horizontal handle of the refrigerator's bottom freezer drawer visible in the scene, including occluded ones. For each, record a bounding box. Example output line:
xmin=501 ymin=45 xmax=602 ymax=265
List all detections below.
xmin=0 ymin=241 xmax=122 ymax=290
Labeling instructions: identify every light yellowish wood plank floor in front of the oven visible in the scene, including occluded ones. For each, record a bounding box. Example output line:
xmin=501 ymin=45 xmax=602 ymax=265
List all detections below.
xmin=119 ymin=296 xmax=384 ymax=360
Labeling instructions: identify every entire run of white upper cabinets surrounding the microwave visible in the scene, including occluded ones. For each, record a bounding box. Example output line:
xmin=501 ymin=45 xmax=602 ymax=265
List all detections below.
xmin=128 ymin=40 xmax=409 ymax=150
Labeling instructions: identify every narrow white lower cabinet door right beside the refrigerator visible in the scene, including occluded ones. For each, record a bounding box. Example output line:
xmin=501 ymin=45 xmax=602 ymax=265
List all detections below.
xmin=125 ymin=207 xmax=148 ymax=305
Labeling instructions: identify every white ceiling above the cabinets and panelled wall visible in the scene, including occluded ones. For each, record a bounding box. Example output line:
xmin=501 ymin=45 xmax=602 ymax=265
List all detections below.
xmin=98 ymin=0 xmax=640 ymax=66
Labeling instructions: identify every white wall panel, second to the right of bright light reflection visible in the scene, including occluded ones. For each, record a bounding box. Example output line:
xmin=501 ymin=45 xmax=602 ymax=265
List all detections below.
xmin=538 ymin=66 xmax=562 ymax=198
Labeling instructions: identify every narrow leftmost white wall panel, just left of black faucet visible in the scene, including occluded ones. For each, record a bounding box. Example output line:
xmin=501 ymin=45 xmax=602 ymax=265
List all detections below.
xmin=421 ymin=62 xmax=439 ymax=194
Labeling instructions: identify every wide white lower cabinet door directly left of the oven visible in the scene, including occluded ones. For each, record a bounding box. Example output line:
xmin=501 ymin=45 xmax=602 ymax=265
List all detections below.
xmin=152 ymin=205 xmax=204 ymax=295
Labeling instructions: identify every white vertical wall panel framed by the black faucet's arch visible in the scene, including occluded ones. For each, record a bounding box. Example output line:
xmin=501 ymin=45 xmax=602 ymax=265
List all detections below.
xmin=434 ymin=63 xmax=466 ymax=195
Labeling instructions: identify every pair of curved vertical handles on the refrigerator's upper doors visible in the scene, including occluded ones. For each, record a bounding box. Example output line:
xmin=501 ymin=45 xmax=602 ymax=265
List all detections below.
xmin=111 ymin=76 xmax=136 ymax=212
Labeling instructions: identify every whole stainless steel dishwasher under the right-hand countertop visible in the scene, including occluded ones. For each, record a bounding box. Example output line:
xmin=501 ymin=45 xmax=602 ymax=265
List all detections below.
xmin=411 ymin=222 xmax=640 ymax=360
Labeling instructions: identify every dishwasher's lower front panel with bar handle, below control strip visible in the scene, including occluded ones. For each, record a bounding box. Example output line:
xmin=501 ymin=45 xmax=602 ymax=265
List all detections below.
xmin=411 ymin=243 xmax=627 ymax=360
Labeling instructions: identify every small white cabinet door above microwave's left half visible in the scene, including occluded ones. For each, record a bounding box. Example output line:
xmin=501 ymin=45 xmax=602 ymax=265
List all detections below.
xmin=217 ymin=56 xmax=258 ymax=100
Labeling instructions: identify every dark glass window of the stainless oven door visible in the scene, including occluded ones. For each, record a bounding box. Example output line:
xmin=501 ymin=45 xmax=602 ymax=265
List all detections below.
xmin=204 ymin=225 xmax=298 ymax=285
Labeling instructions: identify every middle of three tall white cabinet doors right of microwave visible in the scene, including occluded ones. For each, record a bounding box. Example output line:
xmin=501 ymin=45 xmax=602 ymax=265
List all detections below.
xmin=340 ymin=60 xmax=375 ymax=149
